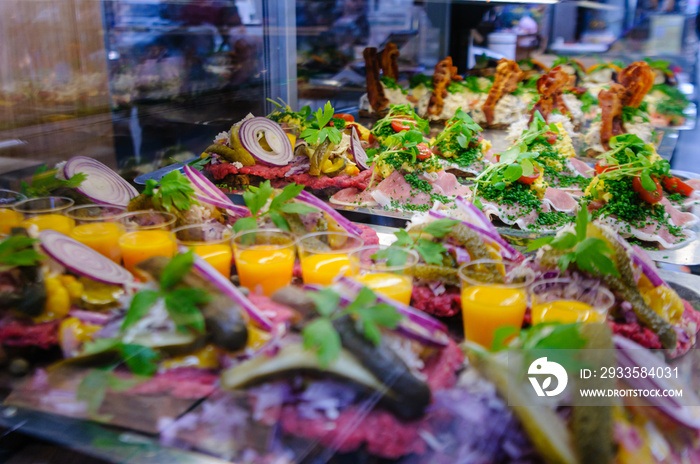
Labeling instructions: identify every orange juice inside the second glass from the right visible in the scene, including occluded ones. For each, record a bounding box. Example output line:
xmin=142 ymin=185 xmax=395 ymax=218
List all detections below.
xmin=462 ymin=284 xmax=527 ymax=349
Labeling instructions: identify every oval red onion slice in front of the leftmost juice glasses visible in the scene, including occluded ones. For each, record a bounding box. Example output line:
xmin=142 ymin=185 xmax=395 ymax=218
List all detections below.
xmin=39 ymin=230 xmax=134 ymax=286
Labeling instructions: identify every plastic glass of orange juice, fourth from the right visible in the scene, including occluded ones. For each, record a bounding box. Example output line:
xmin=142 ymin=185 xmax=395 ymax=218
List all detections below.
xmin=297 ymin=232 xmax=364 ymax=285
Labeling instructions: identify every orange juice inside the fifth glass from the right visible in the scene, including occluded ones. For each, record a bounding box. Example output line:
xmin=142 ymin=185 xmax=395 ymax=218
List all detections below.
xmin=236 ymin=245 xmax=294 ymax=296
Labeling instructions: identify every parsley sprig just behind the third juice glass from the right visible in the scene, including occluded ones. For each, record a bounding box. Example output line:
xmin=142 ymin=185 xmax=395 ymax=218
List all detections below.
xmin=372 ymin=218 xmax=459 ymax=266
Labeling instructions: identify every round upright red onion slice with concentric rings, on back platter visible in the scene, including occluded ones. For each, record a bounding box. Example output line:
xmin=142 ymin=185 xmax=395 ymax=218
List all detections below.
xmin=238 ymin=117 xmax=294 ymax=166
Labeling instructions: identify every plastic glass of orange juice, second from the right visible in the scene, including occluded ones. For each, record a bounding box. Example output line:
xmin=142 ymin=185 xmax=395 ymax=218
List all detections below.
xmin=458 ymin=259 xmax=533 ymax=349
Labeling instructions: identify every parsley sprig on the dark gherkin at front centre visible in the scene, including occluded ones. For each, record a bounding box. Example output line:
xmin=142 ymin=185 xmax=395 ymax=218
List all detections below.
xmin=301 ymin=287 xmax=403 ymax=367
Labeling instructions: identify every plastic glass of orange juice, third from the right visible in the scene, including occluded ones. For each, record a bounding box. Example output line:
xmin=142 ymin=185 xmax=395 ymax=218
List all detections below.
xmin=350 ymin=245 xmax=419 ymax=305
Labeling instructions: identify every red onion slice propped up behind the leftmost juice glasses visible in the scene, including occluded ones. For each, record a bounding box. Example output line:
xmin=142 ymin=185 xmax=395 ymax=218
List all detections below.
xmin=63 ymin=156 xmax=139 ymax=206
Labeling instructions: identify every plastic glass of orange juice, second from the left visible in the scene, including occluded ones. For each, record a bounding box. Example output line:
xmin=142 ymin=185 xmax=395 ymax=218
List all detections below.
xmin=12 ymin=197 xmax=75 ymax=235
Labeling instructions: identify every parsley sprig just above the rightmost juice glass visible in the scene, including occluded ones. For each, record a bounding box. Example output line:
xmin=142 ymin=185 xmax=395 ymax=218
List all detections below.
xmin=527 ymin=208 xmax=620 ymax=277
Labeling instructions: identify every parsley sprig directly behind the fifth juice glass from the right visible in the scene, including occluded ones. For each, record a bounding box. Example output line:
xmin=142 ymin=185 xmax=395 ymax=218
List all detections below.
xmin=233 ymin=180 xmax=318 ymax=232
